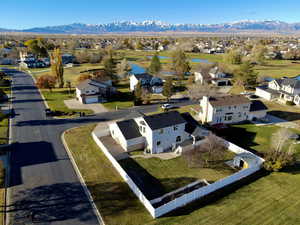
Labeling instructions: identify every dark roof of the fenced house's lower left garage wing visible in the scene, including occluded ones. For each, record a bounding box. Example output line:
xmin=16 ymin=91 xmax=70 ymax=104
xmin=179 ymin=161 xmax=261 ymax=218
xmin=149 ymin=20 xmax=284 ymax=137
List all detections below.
xmin=116 ymin=119 xmax=142 ymax=140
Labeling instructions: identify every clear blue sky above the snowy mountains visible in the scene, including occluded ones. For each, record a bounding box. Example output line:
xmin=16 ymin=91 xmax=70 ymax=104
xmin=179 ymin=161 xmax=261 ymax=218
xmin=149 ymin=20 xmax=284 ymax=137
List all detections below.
xmin=0 ymin=0 xmax=300 ymax=29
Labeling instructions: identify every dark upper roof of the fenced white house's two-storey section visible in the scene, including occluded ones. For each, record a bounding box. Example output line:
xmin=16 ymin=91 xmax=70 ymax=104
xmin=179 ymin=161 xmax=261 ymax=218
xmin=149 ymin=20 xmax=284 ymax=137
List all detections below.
xmin=144 ymin=111 xmax=186 ymax=130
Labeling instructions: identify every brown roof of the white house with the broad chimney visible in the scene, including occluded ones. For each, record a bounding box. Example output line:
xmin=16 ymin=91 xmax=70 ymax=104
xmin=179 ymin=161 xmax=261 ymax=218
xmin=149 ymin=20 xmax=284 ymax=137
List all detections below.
xmin=209 ymin=95 xmax=250 ymax=106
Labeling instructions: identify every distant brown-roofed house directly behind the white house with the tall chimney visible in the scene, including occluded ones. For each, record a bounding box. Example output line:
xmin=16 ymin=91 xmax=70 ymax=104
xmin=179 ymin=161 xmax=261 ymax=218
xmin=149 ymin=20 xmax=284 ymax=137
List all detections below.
xmin=194 ymin=66 xmax=231 ymax=86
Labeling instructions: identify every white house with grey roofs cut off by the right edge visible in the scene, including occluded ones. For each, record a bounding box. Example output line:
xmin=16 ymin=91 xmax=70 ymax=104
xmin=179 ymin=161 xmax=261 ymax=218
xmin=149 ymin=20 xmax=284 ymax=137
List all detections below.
xmin=255 ymin=78 xmax=300 ymax=105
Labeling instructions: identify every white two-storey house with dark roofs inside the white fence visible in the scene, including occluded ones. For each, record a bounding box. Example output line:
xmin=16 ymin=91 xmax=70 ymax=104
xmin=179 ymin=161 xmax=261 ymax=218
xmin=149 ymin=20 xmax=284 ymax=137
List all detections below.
xmin=109 ymin=111 xmax=207 ymax=154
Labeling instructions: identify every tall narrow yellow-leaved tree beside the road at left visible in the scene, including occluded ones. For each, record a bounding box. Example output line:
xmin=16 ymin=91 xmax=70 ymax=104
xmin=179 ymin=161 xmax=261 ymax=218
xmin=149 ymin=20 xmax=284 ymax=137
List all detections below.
xmin=50 ymin=48 xmax=64 ymax=88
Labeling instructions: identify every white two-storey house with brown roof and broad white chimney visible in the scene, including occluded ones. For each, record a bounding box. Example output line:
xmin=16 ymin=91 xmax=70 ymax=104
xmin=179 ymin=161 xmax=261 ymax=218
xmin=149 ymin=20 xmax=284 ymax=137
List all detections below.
xmin=199 ymin=95 xmax=267 ymax=124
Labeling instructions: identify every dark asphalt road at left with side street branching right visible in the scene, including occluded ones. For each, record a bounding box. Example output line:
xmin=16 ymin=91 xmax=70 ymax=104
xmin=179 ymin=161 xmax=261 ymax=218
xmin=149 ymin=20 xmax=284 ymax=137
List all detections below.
xmin=4 ymin=70 xmax=195 ymax=225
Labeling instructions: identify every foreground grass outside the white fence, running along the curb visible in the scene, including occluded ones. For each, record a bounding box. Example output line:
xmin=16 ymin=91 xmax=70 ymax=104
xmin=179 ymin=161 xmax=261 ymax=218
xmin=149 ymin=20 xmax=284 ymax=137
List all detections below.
xmin=66 ymin=125 xmax=300 ymax=225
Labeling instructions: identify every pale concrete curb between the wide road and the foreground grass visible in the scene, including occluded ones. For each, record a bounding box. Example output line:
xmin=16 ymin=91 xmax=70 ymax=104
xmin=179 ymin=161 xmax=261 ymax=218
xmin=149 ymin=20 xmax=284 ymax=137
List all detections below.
xmin=61 ymin=127 xmax=105 ymax=225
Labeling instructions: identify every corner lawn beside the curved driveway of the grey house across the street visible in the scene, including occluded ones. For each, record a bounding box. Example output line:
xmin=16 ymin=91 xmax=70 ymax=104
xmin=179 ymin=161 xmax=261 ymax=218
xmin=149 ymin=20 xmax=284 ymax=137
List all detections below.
xmin=42 ymin=88 xmax=92 ymax=115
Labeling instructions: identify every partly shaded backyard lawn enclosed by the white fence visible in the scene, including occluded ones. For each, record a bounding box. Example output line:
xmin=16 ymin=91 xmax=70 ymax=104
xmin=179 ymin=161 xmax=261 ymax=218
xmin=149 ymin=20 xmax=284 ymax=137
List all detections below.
xmin=120 ymin=152 xmax=234 ymax=194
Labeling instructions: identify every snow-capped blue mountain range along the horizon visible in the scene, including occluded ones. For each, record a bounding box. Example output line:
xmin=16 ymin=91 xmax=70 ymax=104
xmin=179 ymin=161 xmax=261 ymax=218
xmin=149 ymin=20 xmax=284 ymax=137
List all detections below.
xmin=0 ymin=20 xmax=300 ymax=34
